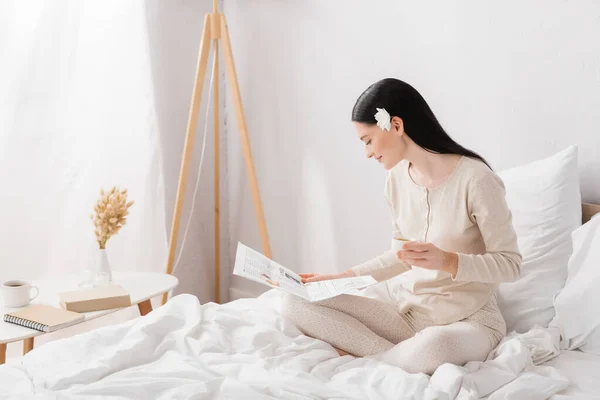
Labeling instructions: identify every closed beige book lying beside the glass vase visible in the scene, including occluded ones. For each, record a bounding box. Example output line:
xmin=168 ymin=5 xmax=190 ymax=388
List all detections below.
xmin=58 ymin=283 xmax=131 ymax=312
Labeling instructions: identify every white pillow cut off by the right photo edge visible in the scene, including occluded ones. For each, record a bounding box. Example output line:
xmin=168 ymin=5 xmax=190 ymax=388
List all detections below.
xmin=550 ymin=218 xmax=600 ymax=355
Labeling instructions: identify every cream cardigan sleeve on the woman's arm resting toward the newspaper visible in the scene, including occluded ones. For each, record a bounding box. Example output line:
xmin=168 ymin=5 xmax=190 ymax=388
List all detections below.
xmin=350 ymin=173 xmax=411 ymax=282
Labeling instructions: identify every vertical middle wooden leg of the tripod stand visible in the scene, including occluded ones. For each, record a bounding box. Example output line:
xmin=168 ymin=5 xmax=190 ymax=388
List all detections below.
xmin=213 ymin=40 xmax=221 ymax=304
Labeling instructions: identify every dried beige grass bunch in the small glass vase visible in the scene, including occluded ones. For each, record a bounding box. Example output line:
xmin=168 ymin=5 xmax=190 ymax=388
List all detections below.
xmin=91 ymin=187 xmax=133 ymax=249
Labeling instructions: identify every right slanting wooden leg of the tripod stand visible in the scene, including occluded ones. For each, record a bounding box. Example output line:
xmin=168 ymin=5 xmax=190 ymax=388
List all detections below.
xmin=221 ymin=15 xmax=271 ymax=258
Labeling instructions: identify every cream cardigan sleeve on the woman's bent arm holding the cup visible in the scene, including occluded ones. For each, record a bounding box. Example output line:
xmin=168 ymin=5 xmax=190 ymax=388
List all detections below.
xmin=453 ymin=172 xmax=522 ymax=283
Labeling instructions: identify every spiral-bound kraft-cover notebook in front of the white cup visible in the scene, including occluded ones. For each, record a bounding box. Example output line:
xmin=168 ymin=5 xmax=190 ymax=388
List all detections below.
xmin=4 ymin=304 xmax=85 ymax=332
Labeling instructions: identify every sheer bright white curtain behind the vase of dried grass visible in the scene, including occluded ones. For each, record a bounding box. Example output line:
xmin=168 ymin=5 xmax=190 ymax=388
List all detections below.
xmin=0 ymin=0 xmax=167 ymax=354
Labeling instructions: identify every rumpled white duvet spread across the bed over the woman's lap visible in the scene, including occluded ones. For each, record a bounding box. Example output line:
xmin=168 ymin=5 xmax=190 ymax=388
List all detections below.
xmin=0 ymin=291 xmax=568 ymax=400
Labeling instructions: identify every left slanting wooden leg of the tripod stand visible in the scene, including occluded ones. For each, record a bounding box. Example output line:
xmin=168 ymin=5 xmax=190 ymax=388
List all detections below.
xmin=162 ymin=14 xmax=210 ymax=304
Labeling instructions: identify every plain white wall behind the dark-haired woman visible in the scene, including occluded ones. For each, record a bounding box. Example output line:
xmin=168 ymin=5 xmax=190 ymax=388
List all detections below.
xmin=225 ymin=0 xmax=600 ymax=295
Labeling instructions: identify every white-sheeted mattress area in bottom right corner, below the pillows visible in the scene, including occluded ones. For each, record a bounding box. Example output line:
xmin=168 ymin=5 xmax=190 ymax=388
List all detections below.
xmin=543 ymin=351 xmax=600 ymax=400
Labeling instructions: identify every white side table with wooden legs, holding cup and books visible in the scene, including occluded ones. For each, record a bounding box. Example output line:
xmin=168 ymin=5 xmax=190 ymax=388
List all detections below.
xmin=0 ymin=272 xmax=178 ymax=364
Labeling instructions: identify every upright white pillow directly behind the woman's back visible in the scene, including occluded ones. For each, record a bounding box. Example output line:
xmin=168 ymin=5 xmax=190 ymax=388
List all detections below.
xmin=497 ymin=146 xmax=581 ymax=333
